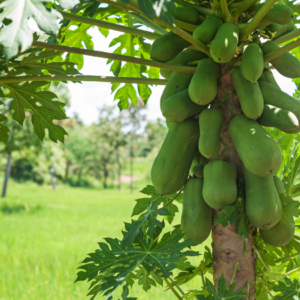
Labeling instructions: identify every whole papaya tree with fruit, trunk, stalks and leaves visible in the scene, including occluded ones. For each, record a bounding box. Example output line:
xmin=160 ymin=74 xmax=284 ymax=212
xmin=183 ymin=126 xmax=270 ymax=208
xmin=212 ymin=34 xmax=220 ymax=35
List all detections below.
xmin=0 ymin=0 xmax=300 ymax=300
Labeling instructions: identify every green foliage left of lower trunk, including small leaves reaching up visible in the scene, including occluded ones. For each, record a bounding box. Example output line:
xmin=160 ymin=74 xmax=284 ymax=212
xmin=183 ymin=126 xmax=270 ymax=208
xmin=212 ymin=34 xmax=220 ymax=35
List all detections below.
xmin=76 ymin=187 xmax=198 ymax=299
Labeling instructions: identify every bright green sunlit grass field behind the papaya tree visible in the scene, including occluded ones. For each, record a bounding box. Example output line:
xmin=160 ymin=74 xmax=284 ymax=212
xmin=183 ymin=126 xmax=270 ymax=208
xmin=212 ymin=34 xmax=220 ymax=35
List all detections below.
xmin=0 ymin=181 xmax=209 ymax=300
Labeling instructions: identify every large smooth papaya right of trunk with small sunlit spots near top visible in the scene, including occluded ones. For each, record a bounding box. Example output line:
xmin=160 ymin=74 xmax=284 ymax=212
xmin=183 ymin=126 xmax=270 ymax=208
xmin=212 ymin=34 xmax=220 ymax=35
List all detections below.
xmin=228 ymin=115 xmax=282 ymax=177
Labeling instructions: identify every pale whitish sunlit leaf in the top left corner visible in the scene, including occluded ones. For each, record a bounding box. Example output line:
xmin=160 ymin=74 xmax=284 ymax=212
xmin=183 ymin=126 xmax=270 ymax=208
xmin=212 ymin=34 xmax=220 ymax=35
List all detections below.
xmin=0 ymin=0 xmax=62 ymax=59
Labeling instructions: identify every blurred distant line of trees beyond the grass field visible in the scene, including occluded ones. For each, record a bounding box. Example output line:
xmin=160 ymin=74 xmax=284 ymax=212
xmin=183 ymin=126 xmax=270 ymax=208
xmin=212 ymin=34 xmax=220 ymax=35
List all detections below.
xmin=0 ymin=102 xmax=167 ymax=196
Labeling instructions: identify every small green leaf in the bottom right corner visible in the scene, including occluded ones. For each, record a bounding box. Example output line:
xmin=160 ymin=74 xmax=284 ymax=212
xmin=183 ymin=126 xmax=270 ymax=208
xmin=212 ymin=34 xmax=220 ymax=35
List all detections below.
xmin=273 ymin=278 xmax=300 ymax=300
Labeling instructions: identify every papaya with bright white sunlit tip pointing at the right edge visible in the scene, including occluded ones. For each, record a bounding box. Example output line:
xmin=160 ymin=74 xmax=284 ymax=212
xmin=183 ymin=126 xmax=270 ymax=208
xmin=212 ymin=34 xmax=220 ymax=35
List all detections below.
xmin=257 ymin=105 xmax=299 ymax=133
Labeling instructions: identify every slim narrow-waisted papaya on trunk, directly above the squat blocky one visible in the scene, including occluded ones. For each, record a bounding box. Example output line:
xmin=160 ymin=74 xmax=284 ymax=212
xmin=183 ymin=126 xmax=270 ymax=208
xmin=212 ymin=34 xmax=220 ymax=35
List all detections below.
xmin=198 ymin=108 xmax=224 ymax=158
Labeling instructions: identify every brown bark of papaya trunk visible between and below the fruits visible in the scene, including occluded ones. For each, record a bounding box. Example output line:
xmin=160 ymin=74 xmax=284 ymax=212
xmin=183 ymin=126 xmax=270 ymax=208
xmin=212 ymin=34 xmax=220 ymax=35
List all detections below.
xmin=212 ymin=71 xmax=256 ymax=300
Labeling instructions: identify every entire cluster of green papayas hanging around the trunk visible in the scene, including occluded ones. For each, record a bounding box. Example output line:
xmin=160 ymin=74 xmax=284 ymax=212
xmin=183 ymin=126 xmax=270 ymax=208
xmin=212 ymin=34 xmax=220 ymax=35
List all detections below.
xmin=151 ymin=4 xmax=300 ymax=247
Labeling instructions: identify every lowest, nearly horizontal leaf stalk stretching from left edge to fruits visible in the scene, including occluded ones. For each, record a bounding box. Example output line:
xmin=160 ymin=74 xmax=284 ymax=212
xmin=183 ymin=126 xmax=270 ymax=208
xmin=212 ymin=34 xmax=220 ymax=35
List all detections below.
xmin=0 ymin=75 xmax=168 ymax=85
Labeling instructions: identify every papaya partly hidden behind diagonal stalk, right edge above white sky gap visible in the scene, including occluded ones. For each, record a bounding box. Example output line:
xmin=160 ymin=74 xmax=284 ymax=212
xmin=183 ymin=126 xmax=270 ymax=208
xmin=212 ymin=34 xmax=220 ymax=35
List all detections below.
xmin=262 ymin=41 xmax=300 ymax=78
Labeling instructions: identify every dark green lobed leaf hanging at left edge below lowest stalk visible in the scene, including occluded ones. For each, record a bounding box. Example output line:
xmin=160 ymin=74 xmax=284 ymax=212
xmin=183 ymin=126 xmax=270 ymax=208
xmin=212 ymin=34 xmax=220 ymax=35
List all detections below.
xmin=1 ymin=82 xmax=67 ymax=142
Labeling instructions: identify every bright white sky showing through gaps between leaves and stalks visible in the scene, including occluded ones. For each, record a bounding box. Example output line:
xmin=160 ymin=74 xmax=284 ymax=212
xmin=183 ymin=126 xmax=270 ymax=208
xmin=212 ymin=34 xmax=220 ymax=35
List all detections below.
xmin=63 ymin=28 xmax=295 ymax=125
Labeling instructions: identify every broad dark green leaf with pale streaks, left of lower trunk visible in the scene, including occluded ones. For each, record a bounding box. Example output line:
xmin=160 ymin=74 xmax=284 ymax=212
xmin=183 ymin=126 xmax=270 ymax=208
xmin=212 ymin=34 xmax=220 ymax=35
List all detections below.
xmin=76 ymin=229 xmax=199 ymax=299
